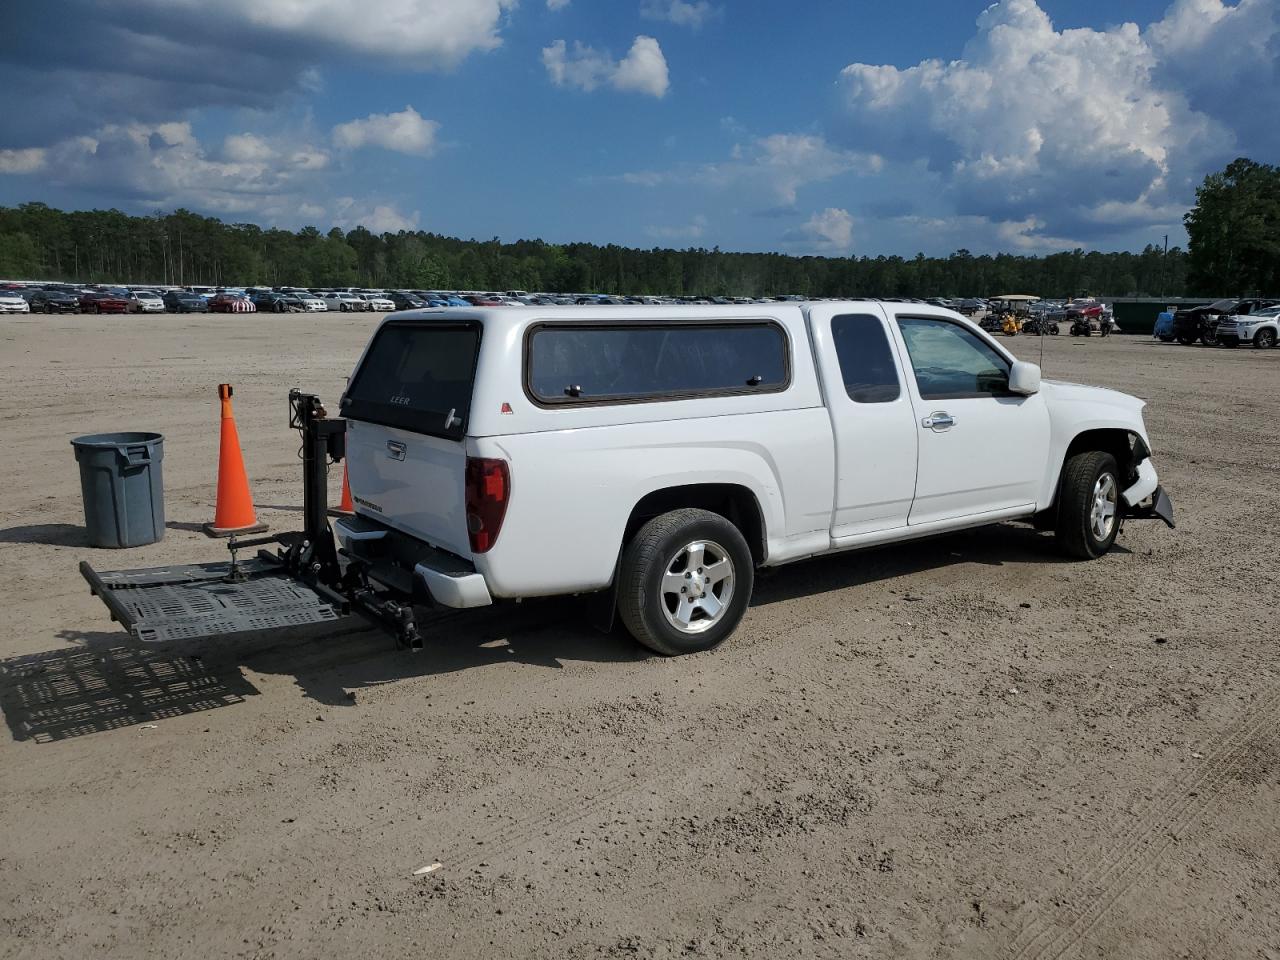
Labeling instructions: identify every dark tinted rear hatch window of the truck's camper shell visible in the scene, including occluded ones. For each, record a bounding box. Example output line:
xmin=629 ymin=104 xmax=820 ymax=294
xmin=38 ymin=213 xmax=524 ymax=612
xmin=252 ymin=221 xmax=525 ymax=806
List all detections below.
xmin=342 ymin=323 xmax=480 ymax=439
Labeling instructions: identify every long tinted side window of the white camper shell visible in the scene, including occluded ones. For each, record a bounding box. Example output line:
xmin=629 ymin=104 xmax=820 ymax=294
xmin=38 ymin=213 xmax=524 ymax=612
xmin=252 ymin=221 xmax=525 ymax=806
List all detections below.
xmin=526 ymin=320 xmax=790 ymax=403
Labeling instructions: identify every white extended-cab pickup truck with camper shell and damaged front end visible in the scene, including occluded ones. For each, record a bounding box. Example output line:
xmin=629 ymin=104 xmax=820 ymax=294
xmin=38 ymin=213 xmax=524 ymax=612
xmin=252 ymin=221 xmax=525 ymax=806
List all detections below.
xmin=334 ymin=301 xmax=1172 ymax=654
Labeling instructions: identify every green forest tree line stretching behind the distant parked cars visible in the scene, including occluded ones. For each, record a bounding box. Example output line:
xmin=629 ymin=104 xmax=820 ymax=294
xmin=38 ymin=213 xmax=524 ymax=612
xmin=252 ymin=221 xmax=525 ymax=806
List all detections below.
xmin=0 ymin=159 xmax=1280 ymax=297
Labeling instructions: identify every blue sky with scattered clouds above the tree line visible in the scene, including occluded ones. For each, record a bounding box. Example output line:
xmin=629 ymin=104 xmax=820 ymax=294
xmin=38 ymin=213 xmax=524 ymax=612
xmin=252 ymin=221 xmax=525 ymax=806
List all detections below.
xmin=0 ymin=0 xmax=1280 ymax=256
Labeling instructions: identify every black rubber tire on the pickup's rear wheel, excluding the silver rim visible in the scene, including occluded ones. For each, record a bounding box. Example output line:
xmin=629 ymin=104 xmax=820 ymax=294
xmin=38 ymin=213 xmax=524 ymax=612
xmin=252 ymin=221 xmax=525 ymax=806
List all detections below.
xmin=617 ymin=508 xmax=755 ymax=657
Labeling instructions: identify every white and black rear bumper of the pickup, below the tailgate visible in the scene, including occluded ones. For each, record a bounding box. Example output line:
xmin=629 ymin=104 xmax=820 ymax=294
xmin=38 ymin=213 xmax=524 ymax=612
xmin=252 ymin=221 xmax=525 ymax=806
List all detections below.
xmin=333 ymin=516 xmax=493 ymax=609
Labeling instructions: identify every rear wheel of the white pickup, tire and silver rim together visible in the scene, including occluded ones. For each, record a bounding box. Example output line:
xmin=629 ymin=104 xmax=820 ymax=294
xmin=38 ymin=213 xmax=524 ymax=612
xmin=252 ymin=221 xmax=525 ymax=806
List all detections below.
xmin=617 ymin=508 xmax=755 ymax=657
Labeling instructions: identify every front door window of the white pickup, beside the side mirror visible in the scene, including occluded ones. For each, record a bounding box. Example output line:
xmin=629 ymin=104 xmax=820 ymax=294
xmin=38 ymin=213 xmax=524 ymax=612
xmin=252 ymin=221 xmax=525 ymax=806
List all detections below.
xmin=897 ymin=317 xmax=1010 ymax=399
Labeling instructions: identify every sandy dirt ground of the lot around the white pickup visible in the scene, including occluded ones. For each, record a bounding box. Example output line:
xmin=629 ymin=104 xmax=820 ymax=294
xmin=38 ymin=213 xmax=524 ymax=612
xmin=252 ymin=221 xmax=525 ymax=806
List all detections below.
xmin=0 ymin=315 xmax=1280 ymax=960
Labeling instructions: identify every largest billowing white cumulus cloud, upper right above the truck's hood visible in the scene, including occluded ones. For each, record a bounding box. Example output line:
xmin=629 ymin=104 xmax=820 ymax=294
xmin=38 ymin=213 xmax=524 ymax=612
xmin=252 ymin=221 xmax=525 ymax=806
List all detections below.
xmin=838 ymin=0 xmax=1280 ymax=247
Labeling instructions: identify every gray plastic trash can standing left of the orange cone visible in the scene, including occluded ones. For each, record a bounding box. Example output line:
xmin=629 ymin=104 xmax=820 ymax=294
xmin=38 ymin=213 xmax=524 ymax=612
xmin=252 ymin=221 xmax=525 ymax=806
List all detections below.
xmin=72 ymin=433 xmax=164 ymax=547
